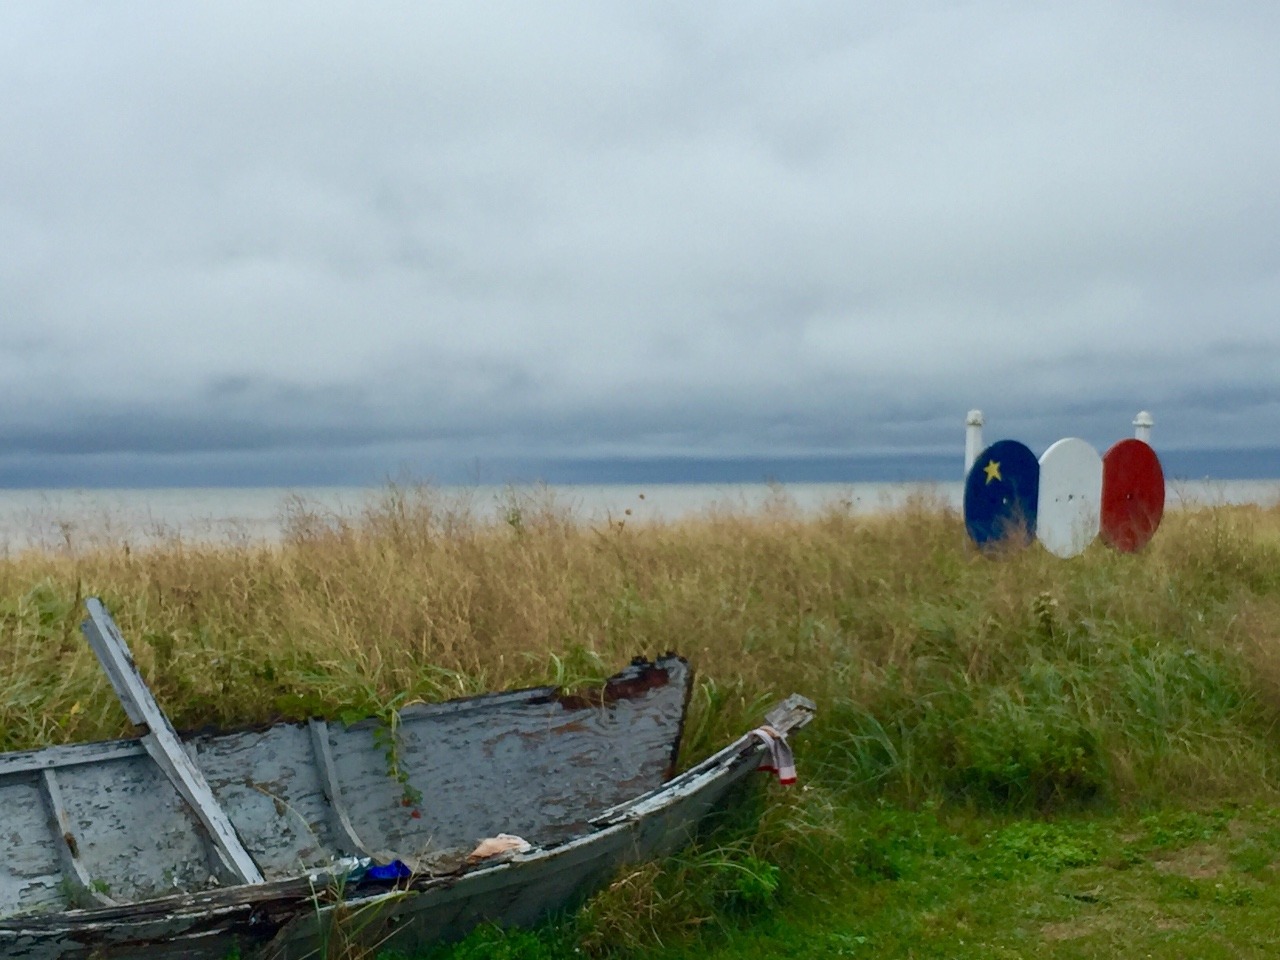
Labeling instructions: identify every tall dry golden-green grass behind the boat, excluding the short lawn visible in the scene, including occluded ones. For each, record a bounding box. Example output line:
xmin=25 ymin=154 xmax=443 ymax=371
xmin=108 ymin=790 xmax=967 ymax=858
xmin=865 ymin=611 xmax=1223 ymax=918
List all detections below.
xmin=0 ymin=488 xmax=1280 ymax=805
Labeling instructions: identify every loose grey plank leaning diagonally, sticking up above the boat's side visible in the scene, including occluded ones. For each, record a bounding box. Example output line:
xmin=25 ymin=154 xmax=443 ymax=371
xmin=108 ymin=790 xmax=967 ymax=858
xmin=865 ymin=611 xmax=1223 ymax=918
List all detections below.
xmin=81 ymin=596 xmax=264 ymax=883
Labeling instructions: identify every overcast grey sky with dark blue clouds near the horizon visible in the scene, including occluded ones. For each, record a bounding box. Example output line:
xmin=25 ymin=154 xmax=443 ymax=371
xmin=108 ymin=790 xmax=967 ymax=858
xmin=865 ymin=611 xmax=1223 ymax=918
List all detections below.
xmin=0 ymin=0 xmax=1280 ymax=485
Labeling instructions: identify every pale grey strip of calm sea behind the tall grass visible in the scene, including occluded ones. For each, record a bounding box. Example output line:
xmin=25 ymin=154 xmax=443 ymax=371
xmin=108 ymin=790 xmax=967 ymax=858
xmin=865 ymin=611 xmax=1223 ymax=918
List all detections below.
xmin=0 ymin=480 xmax=1280 ymax=552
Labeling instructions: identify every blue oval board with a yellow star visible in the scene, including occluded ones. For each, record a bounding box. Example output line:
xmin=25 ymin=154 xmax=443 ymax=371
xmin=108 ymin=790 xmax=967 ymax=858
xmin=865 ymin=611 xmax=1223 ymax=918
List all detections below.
xmin=964 ymin=440 xmax=1039 ymax=547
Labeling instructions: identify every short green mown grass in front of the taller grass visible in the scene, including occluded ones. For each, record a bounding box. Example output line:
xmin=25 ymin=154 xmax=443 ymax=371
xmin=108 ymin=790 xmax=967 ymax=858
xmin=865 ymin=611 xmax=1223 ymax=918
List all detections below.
xmin=407 ymin=806 xmax=1280 ymax=960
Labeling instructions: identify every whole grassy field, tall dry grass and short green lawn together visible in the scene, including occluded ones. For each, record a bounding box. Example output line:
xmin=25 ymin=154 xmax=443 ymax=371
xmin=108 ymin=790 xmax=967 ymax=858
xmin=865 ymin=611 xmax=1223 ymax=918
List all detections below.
xmin=0 ymin=488 xmax=1280 ymax=960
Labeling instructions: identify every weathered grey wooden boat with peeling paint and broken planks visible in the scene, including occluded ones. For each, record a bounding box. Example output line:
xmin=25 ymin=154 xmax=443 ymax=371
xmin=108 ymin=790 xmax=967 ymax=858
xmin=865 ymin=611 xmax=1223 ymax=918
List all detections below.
xmin=0 ymin=600 xmax=814 ymax=960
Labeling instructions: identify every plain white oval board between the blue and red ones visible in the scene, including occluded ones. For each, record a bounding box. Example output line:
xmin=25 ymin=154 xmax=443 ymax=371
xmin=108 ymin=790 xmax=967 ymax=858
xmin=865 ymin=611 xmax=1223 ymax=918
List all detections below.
xmin=1036 ymin=436 xmax=1102 ymax=557
